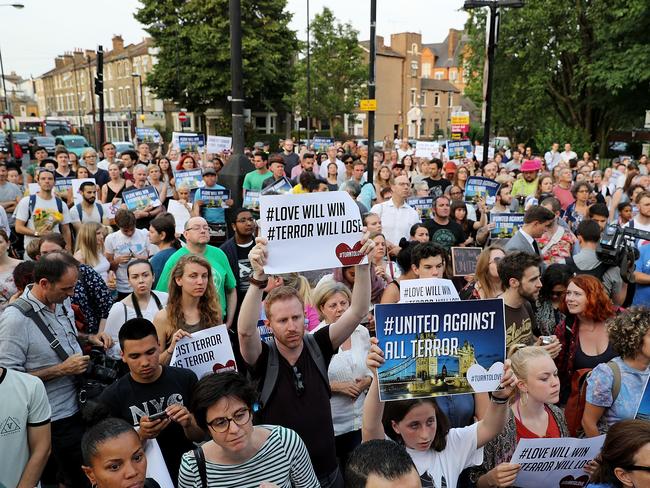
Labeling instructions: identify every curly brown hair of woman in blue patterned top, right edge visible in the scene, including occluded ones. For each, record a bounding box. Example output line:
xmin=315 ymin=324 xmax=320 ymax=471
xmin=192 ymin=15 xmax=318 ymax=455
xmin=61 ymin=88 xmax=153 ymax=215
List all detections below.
xmin=607 ymin=307 xmax=650 ymax=358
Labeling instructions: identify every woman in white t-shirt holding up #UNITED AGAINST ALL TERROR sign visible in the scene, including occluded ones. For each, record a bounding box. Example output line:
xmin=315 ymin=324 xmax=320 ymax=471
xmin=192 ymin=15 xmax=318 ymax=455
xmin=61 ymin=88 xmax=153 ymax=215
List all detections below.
xmin=362 ymin=338 xmax=512 ymax=488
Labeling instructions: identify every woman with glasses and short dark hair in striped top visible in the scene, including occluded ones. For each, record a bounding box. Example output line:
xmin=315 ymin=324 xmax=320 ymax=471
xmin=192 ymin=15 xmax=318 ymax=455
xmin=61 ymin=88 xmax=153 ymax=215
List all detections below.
xmin=178 ymin=372 xmax=320 ymax=488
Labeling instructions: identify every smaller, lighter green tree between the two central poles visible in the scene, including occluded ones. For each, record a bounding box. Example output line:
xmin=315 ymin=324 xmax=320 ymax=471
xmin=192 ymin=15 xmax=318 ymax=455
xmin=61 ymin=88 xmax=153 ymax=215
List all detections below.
xmin=290 ymin=7 xmax=367 ymax=137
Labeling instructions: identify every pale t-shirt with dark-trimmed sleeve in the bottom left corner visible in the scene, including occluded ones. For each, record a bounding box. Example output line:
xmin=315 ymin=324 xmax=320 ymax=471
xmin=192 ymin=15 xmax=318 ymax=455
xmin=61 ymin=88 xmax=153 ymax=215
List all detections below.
xmin=0 ymin=369 xmax=52 ymax=486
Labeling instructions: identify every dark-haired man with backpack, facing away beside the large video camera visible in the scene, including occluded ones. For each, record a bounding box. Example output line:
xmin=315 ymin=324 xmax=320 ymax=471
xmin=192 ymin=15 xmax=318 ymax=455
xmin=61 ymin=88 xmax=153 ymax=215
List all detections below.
xmin=566 ymin=220 xmax=627 ymax=305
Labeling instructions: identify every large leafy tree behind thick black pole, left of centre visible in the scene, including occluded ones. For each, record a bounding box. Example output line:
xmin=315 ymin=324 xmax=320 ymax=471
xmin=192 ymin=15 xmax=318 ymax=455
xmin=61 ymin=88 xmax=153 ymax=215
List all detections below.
xmin=135 ymin=0 xmax=298 ymax=110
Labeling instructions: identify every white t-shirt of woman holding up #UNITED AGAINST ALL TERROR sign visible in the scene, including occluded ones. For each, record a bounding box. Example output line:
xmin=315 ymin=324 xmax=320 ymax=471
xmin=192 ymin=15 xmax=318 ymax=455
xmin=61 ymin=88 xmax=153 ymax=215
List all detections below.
xmin=406 ymin=423 xmax=483 ymax=488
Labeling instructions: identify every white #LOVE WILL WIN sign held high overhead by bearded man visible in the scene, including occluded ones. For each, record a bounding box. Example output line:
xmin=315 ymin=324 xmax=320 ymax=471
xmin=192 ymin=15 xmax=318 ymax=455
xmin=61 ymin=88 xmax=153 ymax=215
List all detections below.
xmin=259 ymin=191 xmax=367 ymax=275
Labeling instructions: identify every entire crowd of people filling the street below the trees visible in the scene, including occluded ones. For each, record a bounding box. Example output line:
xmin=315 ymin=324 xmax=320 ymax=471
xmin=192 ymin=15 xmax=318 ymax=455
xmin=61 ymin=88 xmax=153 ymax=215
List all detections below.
xmin=0 ymin=139 xmax=650 ymax=488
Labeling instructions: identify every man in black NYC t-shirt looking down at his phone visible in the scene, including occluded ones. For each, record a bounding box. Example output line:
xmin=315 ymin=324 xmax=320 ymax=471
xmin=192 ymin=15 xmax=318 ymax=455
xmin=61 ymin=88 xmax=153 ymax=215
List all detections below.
xmin=99 ymin=318 xmax=205 ymax=480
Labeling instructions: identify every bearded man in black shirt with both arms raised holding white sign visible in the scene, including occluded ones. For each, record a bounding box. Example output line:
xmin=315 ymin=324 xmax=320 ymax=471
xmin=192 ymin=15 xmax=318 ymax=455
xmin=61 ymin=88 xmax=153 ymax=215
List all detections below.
xmin=237 ymin=238 xmax=374 ymax=488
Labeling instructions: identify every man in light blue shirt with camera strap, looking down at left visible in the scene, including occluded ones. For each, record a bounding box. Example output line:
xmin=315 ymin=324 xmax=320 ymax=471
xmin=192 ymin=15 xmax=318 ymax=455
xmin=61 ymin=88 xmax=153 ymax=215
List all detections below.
xmin=0 ymin=252 xmax=112 ymax=487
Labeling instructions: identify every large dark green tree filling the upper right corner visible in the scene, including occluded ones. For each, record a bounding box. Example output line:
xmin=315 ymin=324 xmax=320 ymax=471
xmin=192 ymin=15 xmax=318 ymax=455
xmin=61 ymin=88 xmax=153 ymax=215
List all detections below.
xmin=466 ymin=0 xmax=650 ymax=155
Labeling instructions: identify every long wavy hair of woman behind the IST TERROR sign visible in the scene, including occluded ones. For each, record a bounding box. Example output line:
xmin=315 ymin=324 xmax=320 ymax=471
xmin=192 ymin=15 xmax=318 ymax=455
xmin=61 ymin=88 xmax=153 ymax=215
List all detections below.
xmin=166 ymin=254 xmax=222 ymax=331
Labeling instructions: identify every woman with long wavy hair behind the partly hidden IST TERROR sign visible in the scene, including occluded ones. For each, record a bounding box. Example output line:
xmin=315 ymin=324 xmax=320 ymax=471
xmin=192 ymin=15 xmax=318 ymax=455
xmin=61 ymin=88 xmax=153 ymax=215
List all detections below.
xmin=153 ymin=254 xmax=222 ymax=365
